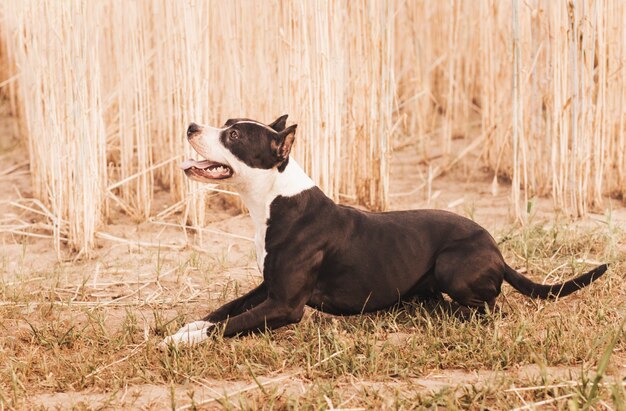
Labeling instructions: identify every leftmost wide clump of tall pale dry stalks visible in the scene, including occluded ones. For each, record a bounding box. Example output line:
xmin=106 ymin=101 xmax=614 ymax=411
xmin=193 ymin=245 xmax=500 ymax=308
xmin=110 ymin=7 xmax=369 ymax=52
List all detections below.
xmin=4 ymin=1 xmax=106 ymax=254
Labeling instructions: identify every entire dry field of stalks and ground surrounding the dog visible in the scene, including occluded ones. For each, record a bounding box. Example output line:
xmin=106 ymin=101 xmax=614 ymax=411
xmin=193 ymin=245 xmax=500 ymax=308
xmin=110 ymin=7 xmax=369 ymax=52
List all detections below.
xmin=0 ymin=0 xmax=626 ymax=410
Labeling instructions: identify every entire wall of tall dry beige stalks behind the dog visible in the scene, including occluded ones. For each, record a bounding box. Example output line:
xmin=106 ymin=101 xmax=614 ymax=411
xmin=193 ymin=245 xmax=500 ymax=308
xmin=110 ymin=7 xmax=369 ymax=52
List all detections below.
xmin=0 ymin=0 xmax=626 ymax=256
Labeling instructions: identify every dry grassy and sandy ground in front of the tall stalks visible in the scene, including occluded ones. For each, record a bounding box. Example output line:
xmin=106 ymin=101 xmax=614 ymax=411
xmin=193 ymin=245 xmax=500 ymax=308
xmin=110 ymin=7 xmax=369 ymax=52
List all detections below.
xmin=0 ymin=99 xmax=626 ymax=410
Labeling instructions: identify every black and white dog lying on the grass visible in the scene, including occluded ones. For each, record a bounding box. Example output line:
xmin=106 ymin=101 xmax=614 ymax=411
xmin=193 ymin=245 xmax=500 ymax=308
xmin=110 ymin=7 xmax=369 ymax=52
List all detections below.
xmin=161 ymin=115 xmax=607 ymax=347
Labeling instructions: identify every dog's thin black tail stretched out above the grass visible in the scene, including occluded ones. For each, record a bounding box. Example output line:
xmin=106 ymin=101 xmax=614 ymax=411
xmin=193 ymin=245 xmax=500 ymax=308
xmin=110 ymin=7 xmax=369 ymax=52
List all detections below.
xmin=504 ymin=264 xmax=608 ymax=300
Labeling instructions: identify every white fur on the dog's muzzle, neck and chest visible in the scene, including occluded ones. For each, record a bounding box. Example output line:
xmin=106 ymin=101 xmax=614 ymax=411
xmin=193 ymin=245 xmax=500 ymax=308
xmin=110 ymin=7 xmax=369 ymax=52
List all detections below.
xmin=184 ymin=120 xmax=315 ymax=272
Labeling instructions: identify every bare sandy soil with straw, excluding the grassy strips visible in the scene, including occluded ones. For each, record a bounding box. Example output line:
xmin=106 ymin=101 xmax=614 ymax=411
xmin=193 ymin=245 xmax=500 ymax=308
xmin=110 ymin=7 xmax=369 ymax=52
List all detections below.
xmin=0 ymin=100 xmax=626 ymax=409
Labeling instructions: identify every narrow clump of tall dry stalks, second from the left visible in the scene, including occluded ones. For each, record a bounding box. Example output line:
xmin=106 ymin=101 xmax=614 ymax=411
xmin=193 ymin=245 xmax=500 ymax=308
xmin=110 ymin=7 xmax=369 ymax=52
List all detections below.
xmin=101 ymin=0 xmax=154 ymax=221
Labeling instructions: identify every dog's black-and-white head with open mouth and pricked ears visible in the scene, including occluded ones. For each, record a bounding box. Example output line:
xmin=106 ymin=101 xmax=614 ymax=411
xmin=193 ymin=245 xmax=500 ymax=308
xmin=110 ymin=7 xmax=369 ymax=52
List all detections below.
xmin=181 ymin=115 xmax=297 ymax=185
